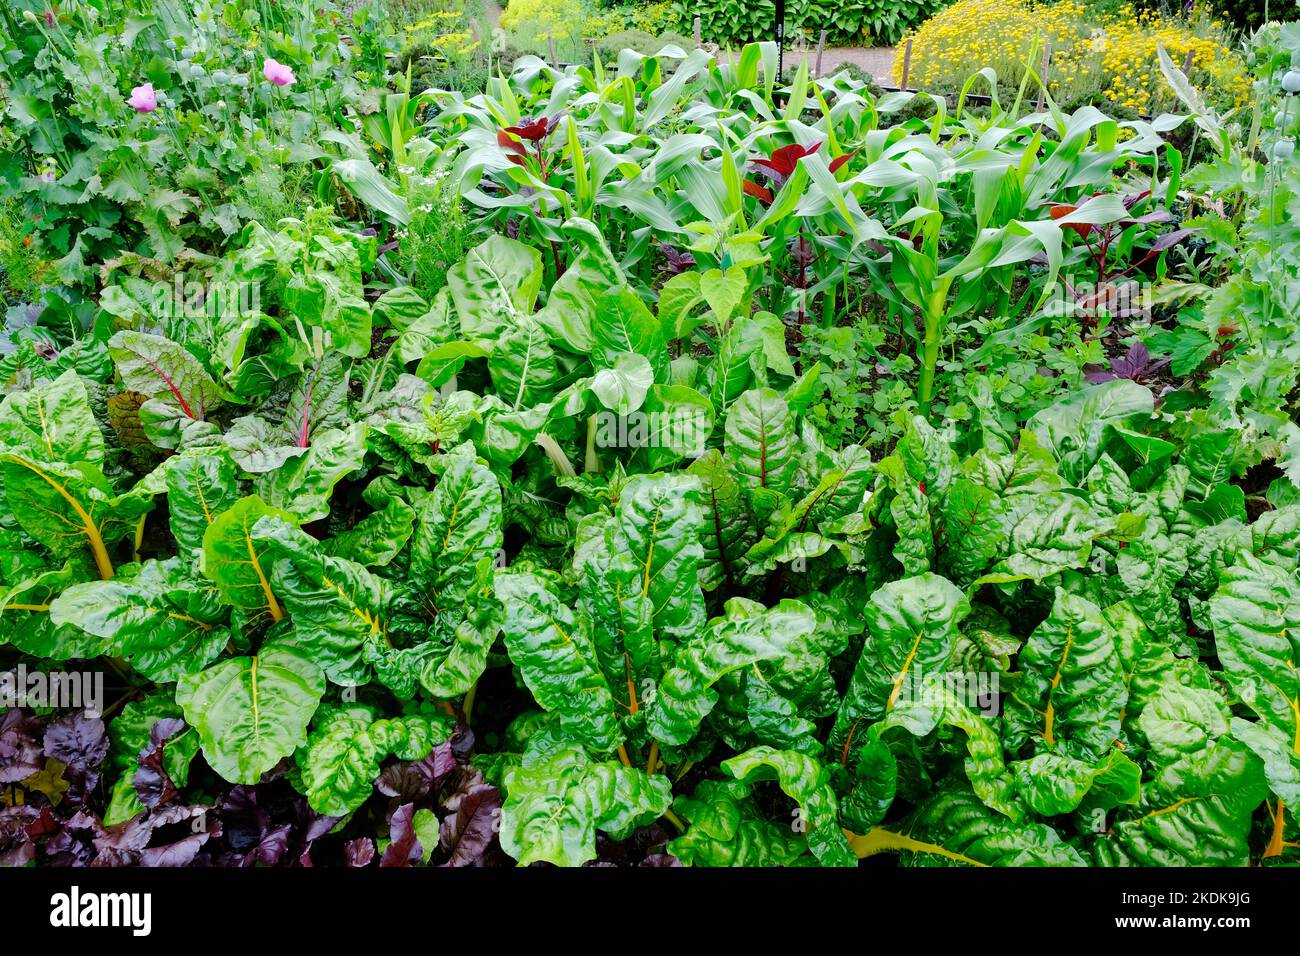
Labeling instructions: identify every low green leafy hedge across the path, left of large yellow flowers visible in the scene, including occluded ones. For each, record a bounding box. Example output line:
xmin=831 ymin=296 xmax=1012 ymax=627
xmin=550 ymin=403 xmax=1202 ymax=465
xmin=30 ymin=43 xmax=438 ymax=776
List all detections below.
xmin=675 ymin=0 xmax=949 ymax=46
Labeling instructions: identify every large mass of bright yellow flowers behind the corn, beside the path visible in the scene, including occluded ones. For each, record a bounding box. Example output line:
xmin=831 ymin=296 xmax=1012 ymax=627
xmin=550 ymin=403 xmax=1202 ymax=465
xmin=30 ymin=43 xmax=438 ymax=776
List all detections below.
xmin=894 ymin=0 xmax=1251 ymax=113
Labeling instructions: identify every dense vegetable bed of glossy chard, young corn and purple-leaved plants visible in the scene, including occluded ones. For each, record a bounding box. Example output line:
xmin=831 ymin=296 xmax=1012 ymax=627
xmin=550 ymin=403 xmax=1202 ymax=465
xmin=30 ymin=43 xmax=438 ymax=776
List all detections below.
xmin=0 ymin=1 xmax=1300 ymax=866
